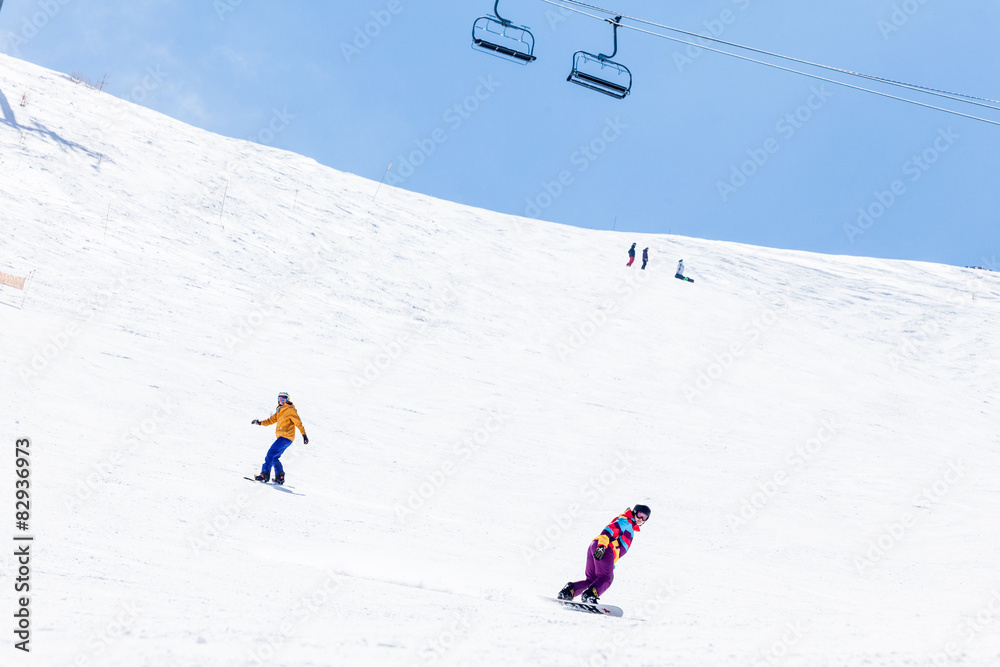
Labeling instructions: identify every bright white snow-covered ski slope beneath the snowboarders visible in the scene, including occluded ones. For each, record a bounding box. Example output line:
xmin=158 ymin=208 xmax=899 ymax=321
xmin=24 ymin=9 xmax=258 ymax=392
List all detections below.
xmin=0 ymin=56 xmax=1000 ymax=666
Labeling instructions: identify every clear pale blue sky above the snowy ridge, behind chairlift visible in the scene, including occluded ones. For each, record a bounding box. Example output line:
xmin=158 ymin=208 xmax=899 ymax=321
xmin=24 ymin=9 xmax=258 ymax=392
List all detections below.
xmin=0 ymin=0 xmax=1000 ymax=268
